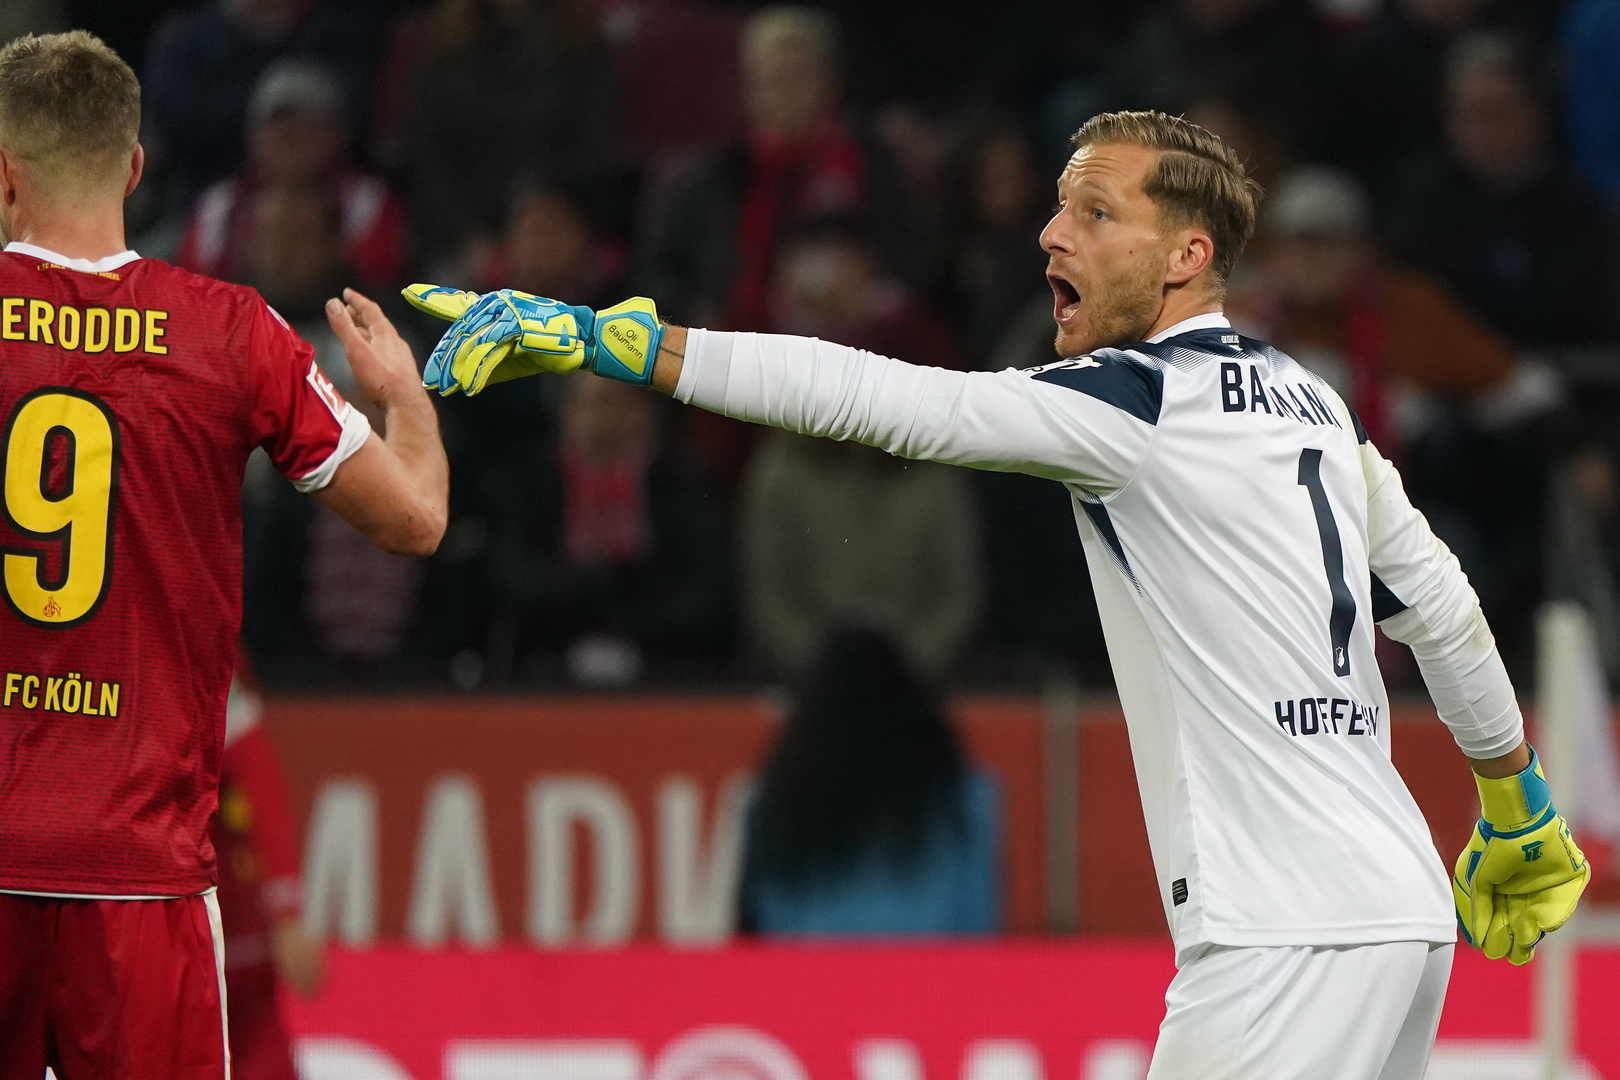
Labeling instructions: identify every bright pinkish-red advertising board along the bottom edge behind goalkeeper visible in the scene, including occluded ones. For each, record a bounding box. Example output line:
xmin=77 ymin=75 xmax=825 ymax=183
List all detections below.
xmin=292 ymin=941 xmax=1620 ymax=1080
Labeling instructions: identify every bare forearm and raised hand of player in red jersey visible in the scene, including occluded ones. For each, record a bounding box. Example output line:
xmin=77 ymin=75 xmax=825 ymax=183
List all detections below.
xmin=314 ymin=288 xmax=450 ymax=555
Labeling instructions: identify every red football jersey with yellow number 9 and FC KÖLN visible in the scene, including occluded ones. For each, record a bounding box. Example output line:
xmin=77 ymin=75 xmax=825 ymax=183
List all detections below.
xmin=0 ymin=244 xmax=369 ymax=897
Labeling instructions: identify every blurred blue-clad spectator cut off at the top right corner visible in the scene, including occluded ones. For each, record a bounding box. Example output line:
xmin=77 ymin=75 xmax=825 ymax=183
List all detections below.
xmin=1563 ymin=0 xmax=1620 ymax=206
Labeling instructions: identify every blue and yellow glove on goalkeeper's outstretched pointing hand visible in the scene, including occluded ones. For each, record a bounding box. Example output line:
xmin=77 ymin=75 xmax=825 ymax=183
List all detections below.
xmin=403 ymin=285 xmax=664 ymax=395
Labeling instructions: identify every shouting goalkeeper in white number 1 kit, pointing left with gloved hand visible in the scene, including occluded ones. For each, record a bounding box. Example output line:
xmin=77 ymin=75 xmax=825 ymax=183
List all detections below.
xmin=407 ymin=113 xmax=1589 ymax=1080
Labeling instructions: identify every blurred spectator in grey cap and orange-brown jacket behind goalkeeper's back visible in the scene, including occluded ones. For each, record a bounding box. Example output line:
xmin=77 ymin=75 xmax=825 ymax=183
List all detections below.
xmin=1231 ymin=165 xmax=1562 ymax=670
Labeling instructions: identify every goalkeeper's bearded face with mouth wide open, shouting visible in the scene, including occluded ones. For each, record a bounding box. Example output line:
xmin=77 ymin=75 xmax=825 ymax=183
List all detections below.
xmin=1040 ymin=142 xmax=1179 ymax=356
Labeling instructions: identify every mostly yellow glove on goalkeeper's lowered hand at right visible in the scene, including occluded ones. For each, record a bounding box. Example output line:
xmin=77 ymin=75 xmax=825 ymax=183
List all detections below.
xmin=1452 ymin=750 xmax=1592 ymax=963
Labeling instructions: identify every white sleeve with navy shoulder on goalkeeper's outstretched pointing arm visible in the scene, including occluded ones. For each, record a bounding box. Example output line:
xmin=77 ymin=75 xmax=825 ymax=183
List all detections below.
xmin=676 ymin=330 xmax=1160 ymax=497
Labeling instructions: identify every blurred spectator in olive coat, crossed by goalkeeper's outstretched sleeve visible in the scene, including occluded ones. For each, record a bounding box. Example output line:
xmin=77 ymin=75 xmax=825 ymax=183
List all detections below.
xmin=739 ymin=222 xmax=983 ymax=678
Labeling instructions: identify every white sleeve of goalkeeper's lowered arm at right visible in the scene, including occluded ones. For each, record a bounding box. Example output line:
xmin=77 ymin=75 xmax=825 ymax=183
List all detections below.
xmin=1361 ymin=442 xmax=1524 ymax=758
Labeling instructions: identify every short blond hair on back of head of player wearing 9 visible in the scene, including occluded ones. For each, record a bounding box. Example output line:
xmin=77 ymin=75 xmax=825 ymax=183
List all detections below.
xmin=0 ymin=31 xmax=141 ymax=185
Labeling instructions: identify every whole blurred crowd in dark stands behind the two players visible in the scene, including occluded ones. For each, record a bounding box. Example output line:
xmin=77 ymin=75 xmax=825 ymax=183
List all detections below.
xmin=28 ymin=0 xmax=1620 ymax=688
